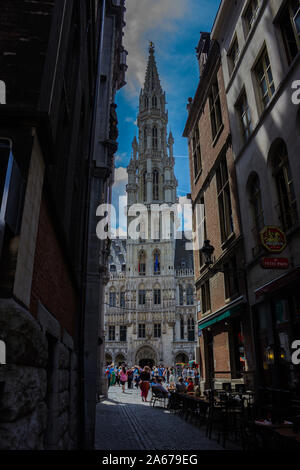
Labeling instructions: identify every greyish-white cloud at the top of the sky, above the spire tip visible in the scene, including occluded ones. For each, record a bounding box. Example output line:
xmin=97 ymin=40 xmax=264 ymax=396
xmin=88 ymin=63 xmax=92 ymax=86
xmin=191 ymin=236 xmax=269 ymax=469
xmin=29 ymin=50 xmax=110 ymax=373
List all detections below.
xmin=124 ymin=0 xmax=190 ymax=98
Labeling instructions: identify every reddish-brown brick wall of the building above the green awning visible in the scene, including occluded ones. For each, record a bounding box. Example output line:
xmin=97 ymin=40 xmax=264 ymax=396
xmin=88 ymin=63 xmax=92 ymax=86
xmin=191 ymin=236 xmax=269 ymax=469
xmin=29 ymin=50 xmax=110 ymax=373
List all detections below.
xmin=184 ymin=37 xmax=245 ymax=388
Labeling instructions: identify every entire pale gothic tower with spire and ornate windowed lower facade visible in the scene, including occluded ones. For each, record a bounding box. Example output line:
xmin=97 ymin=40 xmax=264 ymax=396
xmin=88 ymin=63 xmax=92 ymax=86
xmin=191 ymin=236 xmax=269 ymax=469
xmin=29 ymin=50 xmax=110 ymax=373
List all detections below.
xmin=105 ymin=43 xmax=196 ymax=366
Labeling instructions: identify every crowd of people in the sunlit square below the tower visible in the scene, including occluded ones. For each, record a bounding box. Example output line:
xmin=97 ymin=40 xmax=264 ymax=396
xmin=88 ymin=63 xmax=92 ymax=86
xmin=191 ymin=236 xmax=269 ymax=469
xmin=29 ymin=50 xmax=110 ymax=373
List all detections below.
xmin=105 ymin=363 xmax=200 ymax=402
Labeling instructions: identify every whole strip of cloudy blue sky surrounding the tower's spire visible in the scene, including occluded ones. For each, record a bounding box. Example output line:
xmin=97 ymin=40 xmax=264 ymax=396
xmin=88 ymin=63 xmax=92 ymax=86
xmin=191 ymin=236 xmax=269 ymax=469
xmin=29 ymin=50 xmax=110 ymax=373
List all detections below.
xmin=113 ymin=0 xmax=220 ymax=234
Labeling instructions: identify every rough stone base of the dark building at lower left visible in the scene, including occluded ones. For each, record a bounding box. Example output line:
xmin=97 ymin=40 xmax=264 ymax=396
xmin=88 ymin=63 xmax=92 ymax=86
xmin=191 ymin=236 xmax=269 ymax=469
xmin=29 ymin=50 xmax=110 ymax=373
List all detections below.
xmin=0 ymin=299 xmax=78 ymax=450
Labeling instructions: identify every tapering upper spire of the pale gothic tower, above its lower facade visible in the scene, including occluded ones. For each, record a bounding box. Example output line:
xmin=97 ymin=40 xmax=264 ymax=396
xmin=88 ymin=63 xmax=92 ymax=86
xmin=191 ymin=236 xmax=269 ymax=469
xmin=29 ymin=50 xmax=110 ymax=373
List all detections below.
xmin=128 ymin=42 xmax=177 ymax=209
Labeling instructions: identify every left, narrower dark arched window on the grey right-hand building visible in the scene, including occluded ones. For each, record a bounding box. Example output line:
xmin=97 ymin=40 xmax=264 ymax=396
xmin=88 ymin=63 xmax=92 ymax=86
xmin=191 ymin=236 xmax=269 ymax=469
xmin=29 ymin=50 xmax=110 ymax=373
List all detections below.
xmin=248 ymin=173 xmax=265 ymax=250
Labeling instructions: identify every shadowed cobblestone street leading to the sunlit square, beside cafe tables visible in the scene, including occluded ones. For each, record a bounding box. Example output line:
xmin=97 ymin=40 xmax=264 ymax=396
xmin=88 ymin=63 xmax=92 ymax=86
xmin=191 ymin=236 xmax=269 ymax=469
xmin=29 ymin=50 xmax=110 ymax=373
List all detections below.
xmin=95 ymin=386 xmax=233 ymax=450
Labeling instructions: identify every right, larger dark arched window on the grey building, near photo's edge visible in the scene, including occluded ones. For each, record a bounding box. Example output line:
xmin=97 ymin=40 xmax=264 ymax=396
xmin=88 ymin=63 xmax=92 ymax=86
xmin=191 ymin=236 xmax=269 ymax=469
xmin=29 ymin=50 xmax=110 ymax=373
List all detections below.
xmin=271 ymin=140 xmax=298 ymax=230
